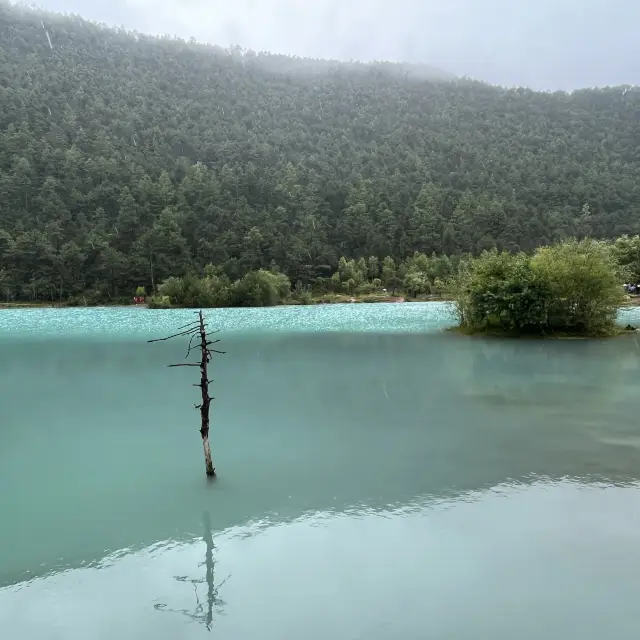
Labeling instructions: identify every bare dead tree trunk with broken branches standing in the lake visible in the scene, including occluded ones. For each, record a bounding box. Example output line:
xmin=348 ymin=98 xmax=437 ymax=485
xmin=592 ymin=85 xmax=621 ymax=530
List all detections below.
xmin=147 ymin=311 xmax=224 ymax=477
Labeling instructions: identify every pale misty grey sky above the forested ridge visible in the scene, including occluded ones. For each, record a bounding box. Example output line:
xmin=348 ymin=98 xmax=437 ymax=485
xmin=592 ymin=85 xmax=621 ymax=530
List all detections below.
xmin=22 ymin=0 xmax=640 ymax=89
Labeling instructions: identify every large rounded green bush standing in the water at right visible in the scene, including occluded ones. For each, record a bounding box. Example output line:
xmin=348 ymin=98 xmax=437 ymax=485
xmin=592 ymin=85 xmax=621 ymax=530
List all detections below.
xmin=448 ymin=239 xmax=623 ymax=335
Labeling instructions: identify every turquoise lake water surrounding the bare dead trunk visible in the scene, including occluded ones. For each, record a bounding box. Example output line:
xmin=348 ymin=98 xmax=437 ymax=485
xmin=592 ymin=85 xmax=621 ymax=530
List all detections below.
xmin=0 ymin=303 xmax=640 ymax=640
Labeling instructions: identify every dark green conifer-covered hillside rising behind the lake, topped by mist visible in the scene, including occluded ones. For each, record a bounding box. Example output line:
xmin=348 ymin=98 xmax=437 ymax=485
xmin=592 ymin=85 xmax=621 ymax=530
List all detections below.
xmin=0 ymin=2 xmax=640 ymax=300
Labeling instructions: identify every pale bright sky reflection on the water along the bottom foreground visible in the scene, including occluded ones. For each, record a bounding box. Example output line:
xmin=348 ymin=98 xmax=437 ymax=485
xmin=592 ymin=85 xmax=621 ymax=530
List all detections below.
xmin=0 ymin=478 xmax=640 ymax=640
